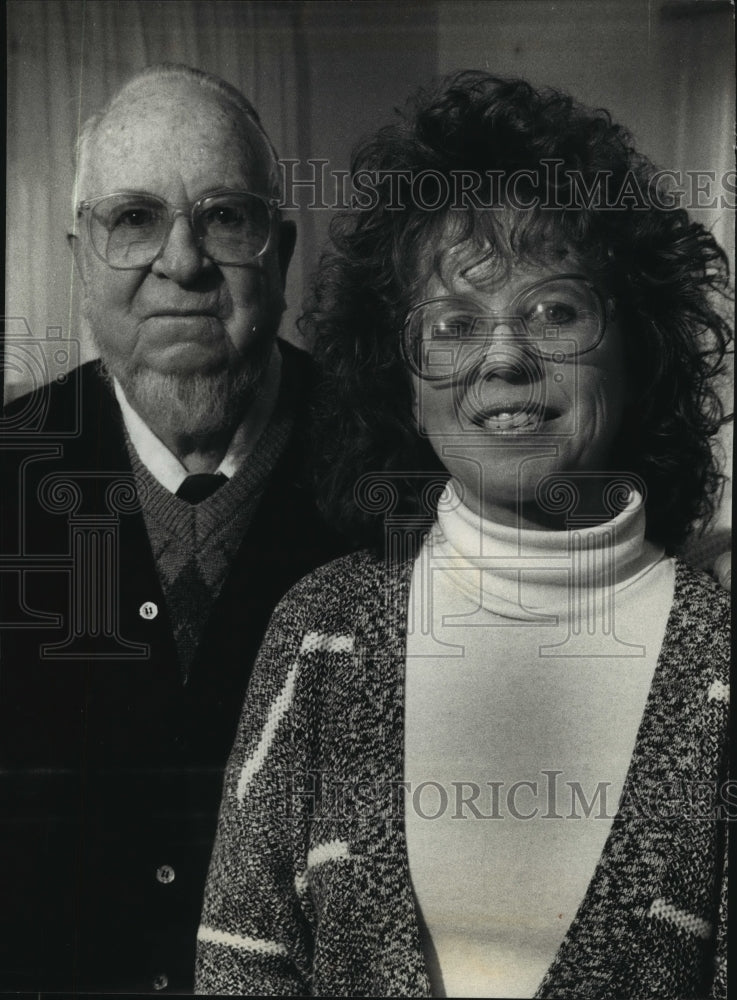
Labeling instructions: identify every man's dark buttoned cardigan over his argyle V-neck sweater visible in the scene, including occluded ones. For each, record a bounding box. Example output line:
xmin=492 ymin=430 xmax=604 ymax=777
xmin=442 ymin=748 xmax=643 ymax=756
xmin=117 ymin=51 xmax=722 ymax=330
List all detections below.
xmin=0 ymin=342 xmax=345 ymax=992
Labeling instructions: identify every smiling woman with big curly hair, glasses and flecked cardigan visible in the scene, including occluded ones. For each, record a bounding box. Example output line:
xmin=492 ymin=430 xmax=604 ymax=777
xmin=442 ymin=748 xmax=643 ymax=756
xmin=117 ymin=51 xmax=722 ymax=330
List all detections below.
xmin=198 ymin=72 xmax=728 ymax=998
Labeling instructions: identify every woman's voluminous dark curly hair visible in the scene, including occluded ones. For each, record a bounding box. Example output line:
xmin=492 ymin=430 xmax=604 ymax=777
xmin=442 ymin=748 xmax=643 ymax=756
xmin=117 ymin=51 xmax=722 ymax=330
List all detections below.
xmin=301 ymin=71 xmax=730 ymax=551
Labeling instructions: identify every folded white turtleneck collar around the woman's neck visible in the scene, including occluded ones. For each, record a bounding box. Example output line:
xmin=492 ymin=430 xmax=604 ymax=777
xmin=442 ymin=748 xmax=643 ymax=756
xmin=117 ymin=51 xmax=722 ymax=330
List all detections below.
xmin=426 ymin=482 xmax=663 ymax=621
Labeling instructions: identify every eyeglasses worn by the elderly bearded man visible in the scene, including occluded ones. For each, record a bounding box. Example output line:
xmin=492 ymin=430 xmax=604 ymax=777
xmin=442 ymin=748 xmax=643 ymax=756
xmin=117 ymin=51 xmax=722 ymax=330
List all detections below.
xmin=78 ymin=191 xmax=277 ymax=271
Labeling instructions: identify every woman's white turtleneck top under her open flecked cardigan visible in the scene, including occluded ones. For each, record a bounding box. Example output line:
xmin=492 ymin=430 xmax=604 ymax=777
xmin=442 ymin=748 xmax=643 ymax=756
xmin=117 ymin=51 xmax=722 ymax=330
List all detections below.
xmin=405 ymin=491 xmax=674 ymax=997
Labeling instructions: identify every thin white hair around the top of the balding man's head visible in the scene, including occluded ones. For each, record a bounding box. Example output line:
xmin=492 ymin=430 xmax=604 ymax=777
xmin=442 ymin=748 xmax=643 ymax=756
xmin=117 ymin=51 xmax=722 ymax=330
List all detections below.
xmin=72 ymin=63 xmax=281 ymax=216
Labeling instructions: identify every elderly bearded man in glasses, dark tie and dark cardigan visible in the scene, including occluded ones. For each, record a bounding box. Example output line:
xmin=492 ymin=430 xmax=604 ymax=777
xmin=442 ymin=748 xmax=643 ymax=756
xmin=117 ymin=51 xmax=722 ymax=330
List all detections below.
xmin=0 ymin=66 xmax=339 ymax=993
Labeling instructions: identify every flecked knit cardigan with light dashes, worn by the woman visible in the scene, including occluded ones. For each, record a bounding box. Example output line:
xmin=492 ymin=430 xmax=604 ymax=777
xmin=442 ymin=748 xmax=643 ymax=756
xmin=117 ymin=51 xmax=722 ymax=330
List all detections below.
xmin=196 ymin=553 xmax=729 ymax=1000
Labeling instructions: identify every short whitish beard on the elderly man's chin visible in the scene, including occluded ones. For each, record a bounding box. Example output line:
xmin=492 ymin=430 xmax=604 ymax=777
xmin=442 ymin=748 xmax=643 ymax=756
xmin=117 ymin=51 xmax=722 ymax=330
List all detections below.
xmin=102 ymin=350 xmax=270 ymax=437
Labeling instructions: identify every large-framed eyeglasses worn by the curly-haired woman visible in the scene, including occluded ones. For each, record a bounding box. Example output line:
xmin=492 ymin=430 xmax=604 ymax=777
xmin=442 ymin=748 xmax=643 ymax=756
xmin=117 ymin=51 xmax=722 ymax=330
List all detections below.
xmin=402 ymin=274 xmax=614 ymax=381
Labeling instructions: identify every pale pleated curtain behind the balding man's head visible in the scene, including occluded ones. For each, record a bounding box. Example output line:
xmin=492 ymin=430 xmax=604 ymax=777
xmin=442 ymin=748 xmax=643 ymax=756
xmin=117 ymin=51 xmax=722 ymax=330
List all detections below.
xmin=6 ymin=0 xmax=304 ymax=399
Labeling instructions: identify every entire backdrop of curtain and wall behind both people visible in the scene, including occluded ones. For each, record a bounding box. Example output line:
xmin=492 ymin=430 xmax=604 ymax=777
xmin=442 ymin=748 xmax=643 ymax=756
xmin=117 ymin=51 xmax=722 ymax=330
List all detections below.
xmin=6 ymin=0 xmax=735 ymax=540
